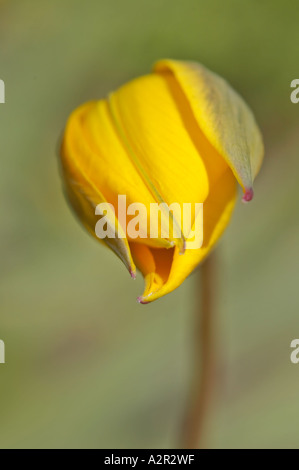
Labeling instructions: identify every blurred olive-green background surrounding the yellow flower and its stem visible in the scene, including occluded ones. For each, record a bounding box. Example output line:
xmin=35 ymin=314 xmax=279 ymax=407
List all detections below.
xmin=0 ymin=0 xmax=299 ymax=448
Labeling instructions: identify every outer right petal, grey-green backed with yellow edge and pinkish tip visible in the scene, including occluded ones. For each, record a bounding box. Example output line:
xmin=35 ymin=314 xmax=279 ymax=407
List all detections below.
xmin=154 ymin=60 xmax=264 ymax=200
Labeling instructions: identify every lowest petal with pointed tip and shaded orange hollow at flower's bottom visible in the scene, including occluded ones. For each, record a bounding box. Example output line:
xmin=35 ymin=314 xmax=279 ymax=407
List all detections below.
xmin=135 ymin=168 xmax=237 ymax=303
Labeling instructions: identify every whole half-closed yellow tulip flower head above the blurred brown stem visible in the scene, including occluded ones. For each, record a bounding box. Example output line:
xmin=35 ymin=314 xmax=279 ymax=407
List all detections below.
xmin=61 ymin=60 xmax=263 ymax=303
